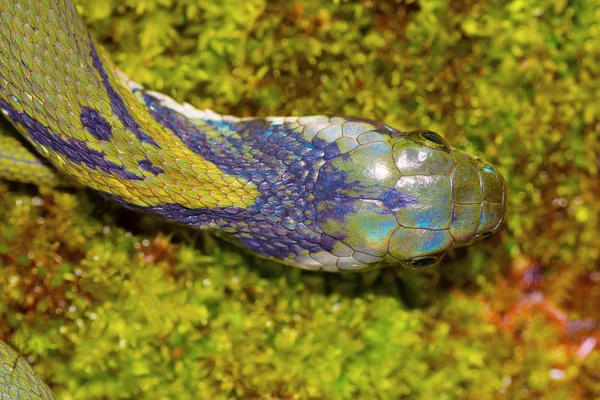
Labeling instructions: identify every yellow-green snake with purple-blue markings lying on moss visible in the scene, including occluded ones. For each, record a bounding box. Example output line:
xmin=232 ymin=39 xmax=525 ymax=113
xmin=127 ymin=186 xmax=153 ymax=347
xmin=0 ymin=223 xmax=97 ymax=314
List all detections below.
xmin=0 ymin=0 xmax=506 ymax=394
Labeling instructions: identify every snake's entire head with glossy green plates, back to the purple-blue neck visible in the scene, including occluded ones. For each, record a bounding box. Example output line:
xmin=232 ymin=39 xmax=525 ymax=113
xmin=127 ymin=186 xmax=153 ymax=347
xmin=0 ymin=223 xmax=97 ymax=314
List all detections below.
xmin=315 ymin=126 xmax=506 ymax=270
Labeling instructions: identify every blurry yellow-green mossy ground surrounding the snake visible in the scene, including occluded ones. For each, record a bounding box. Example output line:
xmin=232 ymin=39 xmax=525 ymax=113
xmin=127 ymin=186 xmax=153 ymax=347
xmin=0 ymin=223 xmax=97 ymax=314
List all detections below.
xmin=0 ymin=0 xmax=600 ymax=399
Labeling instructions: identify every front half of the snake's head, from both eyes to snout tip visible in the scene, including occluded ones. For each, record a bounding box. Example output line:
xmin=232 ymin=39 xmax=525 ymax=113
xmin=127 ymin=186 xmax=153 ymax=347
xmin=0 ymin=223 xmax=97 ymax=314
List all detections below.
xmin=389 ymin=131 xmax=506 ymax=268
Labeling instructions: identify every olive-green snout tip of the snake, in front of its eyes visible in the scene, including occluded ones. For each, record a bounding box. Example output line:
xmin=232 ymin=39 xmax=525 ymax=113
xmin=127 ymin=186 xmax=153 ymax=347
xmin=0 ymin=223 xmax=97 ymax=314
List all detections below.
xmin=450 ymin=159 xmax=506 ymax=246
